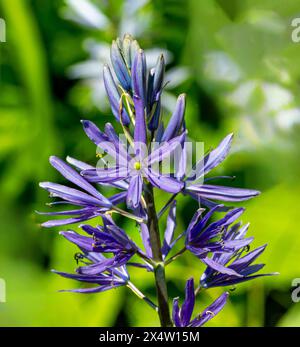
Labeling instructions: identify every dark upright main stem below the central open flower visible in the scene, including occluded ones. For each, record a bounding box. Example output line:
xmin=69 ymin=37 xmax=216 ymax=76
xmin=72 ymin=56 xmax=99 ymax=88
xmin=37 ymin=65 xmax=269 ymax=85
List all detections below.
xmin=145 ymin=183 xmax=172 ymax=327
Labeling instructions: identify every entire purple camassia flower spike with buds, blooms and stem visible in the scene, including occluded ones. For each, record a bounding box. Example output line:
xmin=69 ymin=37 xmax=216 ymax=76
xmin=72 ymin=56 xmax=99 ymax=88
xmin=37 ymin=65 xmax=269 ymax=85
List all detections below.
xmin=40 ymin=35 xmax=274 ymax=327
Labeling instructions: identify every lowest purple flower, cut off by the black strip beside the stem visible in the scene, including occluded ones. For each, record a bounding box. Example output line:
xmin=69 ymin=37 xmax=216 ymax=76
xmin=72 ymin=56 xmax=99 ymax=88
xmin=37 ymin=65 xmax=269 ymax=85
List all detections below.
xmin=172 ymin=278 xmax=228 ymax=327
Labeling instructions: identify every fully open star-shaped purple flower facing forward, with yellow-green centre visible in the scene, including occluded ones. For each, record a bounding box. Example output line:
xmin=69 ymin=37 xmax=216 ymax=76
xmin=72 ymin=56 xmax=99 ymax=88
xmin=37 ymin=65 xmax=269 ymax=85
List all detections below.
xmin=81 ymin=121 xmax=185 ymax=208
